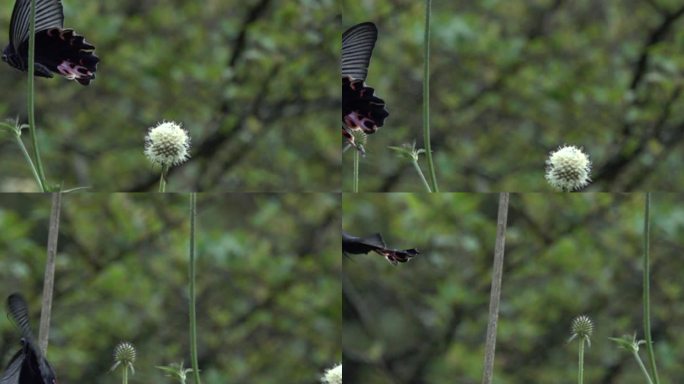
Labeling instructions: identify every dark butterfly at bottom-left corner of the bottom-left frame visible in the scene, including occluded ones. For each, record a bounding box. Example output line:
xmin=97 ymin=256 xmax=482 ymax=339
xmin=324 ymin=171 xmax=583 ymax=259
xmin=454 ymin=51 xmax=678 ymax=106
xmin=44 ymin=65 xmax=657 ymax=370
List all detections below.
xmin=0 ymin=293 xmax=57 ymax=384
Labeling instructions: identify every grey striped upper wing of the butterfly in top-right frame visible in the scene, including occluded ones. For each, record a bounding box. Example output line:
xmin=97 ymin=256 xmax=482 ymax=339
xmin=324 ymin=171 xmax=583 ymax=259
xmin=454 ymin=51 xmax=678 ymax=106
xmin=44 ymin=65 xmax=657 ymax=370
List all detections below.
xmin=342 ymin=22 xmax=378 ymax=80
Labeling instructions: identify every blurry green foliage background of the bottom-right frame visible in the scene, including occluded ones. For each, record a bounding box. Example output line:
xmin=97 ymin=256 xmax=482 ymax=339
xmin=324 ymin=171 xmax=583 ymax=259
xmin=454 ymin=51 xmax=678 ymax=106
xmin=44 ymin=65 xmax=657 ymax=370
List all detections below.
xmin=342 ymin=193 xmax=684 ymax=384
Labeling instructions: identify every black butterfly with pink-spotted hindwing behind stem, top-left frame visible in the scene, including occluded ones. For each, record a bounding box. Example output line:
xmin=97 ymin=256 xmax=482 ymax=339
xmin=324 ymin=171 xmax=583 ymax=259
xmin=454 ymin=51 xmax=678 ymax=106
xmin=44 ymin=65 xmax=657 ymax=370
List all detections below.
xmin=2 ymin=0 xmax=100 ymax=85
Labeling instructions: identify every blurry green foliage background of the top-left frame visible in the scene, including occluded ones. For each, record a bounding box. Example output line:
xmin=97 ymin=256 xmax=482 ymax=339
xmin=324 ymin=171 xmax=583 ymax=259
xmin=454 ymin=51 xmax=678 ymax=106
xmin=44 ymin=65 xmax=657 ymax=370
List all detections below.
xmin=0 ymin=0 xmax=341 ymax=192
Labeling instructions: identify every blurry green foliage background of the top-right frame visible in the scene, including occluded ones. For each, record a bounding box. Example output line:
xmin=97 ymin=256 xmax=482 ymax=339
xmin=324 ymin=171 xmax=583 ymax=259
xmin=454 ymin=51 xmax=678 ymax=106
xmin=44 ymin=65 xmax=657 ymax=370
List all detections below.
xmin=342 ymin=0 xmax=684 ymax=192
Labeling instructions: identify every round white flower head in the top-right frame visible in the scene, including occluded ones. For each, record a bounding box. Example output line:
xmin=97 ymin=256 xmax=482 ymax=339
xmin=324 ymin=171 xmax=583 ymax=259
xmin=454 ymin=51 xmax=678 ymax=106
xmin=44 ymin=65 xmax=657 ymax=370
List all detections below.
xmin=546 ymin=145 xmax=591 ymax=192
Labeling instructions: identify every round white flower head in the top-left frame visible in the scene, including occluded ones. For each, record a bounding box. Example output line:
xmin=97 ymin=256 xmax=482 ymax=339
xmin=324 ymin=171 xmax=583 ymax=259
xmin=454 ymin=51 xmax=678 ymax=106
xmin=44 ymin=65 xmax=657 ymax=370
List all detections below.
xmin=145 ymin=121 xmax=190 ymax=167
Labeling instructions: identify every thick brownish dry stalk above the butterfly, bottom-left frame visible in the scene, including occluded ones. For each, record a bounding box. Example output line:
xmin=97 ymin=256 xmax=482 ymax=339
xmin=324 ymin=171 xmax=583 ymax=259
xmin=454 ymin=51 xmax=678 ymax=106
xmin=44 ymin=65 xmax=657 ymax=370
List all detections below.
xmin=38 ymin=192 xmax=62 ymax=355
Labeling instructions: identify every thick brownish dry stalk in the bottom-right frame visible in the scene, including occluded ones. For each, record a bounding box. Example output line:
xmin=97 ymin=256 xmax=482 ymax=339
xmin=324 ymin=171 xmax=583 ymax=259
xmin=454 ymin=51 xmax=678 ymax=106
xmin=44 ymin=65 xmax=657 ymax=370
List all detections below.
xmin=482 ymin=192 xmax=510 ymax=384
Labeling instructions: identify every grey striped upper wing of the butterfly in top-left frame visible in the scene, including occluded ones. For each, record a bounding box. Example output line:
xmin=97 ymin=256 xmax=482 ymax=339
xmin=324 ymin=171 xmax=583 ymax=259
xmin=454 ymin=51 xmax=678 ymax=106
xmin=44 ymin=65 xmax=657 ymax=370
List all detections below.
xmin=9 ymin=0 xmax=64 ymax=53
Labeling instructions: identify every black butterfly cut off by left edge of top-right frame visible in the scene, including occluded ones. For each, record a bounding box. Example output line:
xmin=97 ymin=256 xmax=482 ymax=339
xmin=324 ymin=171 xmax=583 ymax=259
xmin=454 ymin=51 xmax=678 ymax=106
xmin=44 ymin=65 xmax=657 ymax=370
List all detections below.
xmin=342 ymin=22 xmax=389 ymax=150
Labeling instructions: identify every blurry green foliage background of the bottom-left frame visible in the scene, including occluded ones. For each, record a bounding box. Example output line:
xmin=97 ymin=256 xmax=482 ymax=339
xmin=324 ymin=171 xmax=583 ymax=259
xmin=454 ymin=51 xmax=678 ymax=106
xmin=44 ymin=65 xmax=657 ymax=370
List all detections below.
xmin=0 ymin=194 xmax=342 ymax=384
